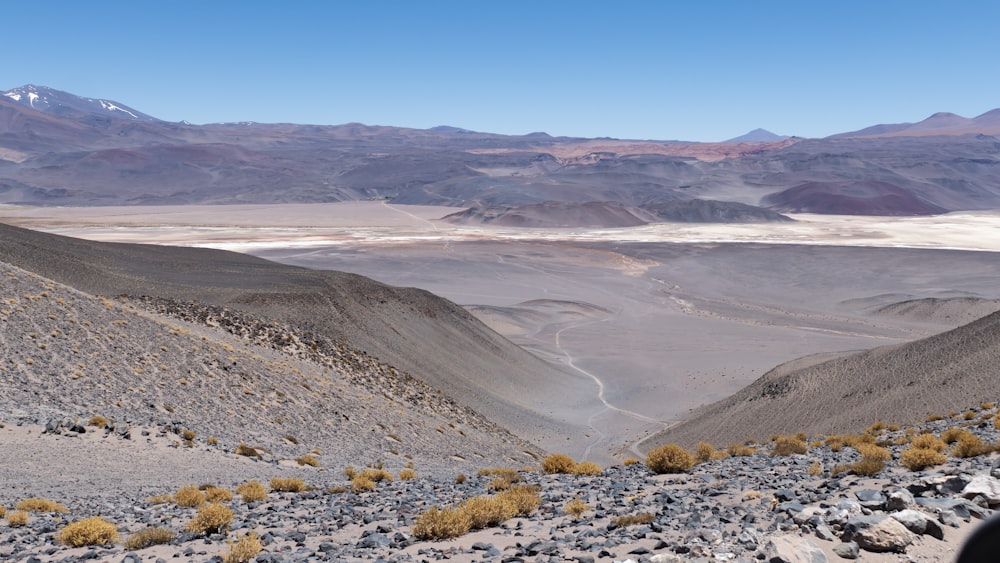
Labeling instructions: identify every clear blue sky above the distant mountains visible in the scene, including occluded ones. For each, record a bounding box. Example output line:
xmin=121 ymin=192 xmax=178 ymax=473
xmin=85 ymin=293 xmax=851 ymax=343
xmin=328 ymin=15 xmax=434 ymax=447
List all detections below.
xmin=7 ymin=0 xmax=1000 ymax=141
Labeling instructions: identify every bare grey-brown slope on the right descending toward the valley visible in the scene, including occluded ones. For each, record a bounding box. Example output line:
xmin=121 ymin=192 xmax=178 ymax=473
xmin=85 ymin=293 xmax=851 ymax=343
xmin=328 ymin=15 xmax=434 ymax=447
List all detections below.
xmin=644 ymin=312 xmax=1000 ymax=448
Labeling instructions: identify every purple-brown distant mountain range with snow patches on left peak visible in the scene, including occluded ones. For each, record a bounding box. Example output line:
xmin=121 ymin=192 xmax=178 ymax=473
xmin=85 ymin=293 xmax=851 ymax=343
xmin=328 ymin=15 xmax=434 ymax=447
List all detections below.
xmin=0 ymin=85 xmax=1000 ymax=220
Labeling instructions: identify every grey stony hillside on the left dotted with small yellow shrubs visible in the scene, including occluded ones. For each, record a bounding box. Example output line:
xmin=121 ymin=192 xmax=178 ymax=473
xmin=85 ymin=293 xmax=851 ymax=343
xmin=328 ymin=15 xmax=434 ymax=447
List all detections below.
xmin=0 ymin=263 xmax=538 ymax=476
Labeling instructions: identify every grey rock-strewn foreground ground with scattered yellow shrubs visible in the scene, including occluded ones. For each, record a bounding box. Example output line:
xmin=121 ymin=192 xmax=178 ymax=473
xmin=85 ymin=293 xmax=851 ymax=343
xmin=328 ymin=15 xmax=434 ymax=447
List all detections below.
xmin=0 ymin=408 xmax=1000 ymax=562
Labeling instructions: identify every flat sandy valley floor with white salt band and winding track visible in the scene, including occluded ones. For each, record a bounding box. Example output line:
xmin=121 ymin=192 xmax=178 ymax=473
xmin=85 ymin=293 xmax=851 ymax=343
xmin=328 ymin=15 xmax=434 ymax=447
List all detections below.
xmin=0 ymin=202 xmax=1000 ymax=462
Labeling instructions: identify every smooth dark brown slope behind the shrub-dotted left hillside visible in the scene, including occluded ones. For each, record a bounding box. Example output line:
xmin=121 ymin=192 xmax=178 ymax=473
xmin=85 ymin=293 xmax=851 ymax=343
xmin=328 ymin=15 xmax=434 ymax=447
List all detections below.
xmin=0 ymin=225 xmax=588 ymax=456
